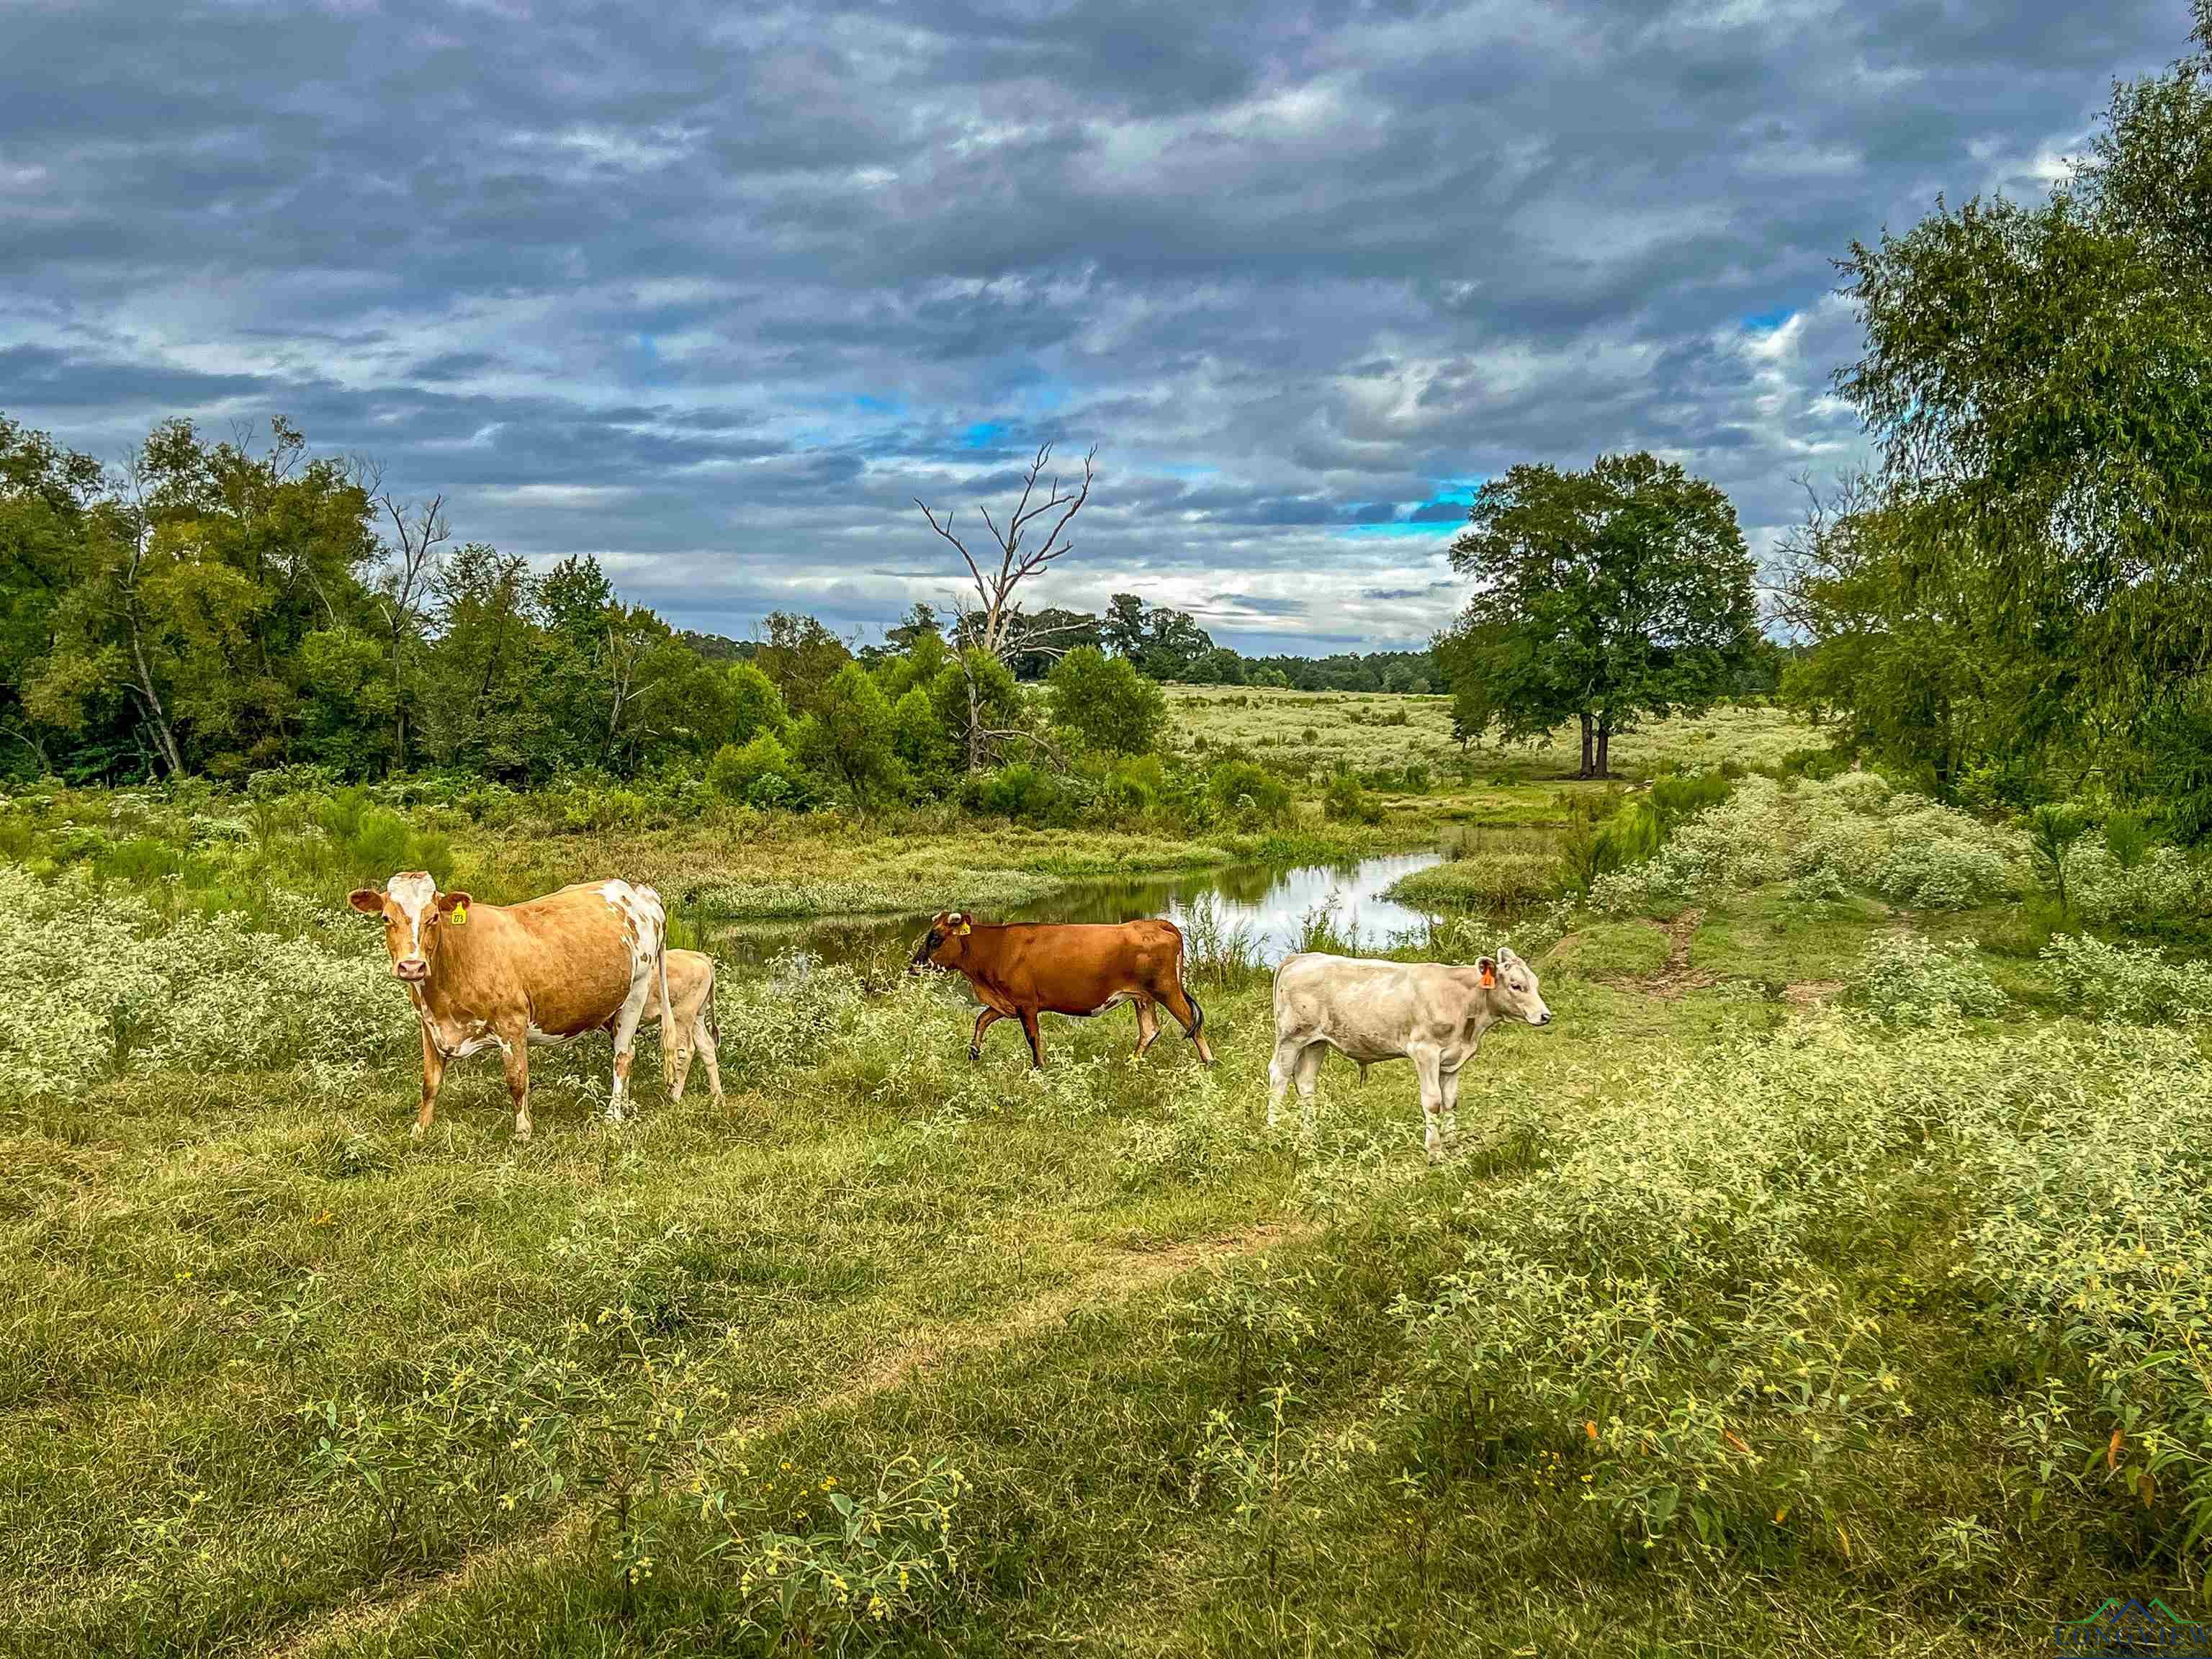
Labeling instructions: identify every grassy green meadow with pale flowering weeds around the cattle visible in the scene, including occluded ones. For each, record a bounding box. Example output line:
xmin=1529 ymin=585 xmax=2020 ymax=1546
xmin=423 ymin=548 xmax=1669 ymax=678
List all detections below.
xmin=0 ymin=690 xmax=2212 ymax=1657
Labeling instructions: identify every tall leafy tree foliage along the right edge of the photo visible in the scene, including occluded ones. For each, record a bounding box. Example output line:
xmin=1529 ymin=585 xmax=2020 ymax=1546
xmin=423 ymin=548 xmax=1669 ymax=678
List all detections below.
xmin=1799 ymin=4 xmax=2212 ymax=836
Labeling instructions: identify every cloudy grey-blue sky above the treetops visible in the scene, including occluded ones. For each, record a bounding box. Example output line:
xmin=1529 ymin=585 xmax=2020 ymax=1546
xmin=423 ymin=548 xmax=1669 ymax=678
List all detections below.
xmin=0 ymin=0 xmax=2188 ymax=652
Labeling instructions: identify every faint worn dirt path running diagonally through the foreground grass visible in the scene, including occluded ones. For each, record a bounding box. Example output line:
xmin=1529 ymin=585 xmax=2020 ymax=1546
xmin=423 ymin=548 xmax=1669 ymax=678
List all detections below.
xmin=258 ymin=1221 xmax=1312 ymax=1659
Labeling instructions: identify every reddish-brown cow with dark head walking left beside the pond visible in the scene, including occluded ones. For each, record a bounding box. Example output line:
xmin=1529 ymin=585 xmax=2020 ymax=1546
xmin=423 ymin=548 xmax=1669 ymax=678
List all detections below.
xmin=907 ymin=909 xmax=1215 ymax=1066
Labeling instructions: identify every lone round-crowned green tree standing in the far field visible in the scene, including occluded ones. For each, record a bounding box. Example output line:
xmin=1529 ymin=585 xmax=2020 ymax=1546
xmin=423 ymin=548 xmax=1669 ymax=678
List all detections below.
xmin=1447 ymin=454 xmax=1758 ymax=776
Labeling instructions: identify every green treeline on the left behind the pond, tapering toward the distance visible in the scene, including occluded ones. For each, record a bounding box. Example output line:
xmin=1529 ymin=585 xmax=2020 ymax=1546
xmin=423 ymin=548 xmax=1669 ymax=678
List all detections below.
xmin=0 ymin=416 xmax=1442 ymax=803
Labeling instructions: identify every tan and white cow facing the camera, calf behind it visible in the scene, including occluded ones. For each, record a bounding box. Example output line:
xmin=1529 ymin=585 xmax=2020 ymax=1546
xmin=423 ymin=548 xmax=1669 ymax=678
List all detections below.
xmin=347 ymin=869 xmax=673 ymax=1141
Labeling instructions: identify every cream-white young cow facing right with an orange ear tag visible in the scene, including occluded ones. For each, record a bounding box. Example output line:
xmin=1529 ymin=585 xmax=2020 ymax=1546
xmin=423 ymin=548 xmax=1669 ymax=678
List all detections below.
xmin=1267 ymin=949 xmax=1550 ymax=1164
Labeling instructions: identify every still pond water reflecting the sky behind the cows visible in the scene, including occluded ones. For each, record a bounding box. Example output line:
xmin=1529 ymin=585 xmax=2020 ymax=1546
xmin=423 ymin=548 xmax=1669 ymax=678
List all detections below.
xmin=716 ymin=852 xmax=1442 ymax=981
